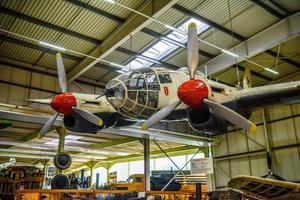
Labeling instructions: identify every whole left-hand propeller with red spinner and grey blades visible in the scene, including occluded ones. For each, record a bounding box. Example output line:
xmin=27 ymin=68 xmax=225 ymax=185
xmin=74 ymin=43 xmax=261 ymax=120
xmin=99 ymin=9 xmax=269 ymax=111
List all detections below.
xmin=37 ymin=53 xmax=103 ymax=137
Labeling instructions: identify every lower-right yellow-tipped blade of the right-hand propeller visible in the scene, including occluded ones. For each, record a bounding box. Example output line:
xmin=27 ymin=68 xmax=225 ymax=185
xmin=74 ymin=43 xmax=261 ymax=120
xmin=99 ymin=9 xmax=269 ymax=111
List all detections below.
xmin=203 ymin=99 xmax=257 ymax=133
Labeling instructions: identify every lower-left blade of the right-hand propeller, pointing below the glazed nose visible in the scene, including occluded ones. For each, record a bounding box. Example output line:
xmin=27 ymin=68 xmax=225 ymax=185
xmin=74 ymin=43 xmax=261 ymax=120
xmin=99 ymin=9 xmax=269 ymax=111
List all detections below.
xmin=141 ymin=100 xmax=181 ymax=130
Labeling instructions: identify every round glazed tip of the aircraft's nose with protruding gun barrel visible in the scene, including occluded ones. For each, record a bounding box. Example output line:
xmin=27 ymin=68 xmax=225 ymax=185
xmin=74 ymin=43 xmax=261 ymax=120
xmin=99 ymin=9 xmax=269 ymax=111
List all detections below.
xmin=106 ymin=80 xmax=126 ymax=108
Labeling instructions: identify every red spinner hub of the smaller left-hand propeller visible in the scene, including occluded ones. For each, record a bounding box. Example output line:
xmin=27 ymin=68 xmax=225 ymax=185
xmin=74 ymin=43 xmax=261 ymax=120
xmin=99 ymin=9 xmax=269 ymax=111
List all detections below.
xmin=50 ymin=93 xmax=76 ymax=116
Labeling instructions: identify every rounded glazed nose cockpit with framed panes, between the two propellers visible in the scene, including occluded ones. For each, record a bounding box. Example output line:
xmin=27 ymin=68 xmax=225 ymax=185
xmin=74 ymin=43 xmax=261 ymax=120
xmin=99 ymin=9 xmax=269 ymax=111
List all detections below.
xmin=106 ymin=69 xmax=159 ymax=119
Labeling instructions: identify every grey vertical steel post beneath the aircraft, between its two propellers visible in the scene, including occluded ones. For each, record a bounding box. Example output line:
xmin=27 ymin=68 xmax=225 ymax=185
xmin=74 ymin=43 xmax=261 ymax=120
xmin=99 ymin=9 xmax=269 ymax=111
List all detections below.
xmin=143 ymin=138 xmax=150 ymax=191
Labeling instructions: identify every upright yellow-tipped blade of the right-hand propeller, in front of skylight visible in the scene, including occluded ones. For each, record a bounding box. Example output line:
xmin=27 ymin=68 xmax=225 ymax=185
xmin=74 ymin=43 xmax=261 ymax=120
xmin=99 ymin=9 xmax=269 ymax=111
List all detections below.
xmin=187 ymin=22 xmax=199 ymax=79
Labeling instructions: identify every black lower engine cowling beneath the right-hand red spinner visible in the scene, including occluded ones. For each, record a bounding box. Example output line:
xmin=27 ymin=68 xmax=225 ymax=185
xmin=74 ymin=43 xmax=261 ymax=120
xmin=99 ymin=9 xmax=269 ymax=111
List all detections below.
xmin=187 ymin=105 xmax=229 ymax=134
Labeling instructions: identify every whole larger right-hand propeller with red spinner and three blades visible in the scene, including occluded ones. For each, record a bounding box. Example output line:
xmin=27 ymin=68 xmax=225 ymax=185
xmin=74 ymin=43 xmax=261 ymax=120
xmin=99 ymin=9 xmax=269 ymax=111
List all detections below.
xmin=142 ymin=23 xmax=256 ymax=132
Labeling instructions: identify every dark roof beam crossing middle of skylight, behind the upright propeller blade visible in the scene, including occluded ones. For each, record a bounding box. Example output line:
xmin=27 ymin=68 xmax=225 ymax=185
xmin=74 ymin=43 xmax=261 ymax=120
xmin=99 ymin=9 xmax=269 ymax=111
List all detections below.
xmin=141 ymin=28 xmax=215 ymax=58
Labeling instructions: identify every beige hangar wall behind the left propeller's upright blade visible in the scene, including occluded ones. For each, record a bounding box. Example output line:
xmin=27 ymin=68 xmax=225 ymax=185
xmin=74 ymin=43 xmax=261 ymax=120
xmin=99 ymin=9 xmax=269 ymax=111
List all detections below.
xmin=0 ymin=65 xmax=102 ymax=109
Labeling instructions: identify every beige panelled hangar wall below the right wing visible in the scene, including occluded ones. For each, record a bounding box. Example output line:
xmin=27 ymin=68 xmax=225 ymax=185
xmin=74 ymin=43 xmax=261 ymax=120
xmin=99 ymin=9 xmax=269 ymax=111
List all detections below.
xmin=213 ymin=104 xmax=300 ymax=188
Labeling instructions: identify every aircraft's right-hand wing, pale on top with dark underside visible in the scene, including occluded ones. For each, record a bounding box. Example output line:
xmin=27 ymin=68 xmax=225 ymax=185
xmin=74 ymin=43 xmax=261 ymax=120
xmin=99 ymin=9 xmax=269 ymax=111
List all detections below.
xmin=230 ymin=81 xmax=300 ymax=108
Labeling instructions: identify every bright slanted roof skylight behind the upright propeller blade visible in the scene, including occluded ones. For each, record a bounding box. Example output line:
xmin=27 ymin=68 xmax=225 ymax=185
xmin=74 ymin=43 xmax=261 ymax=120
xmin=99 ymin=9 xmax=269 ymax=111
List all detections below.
xmin=120 ymin=18 xmax=209 ymax=73
